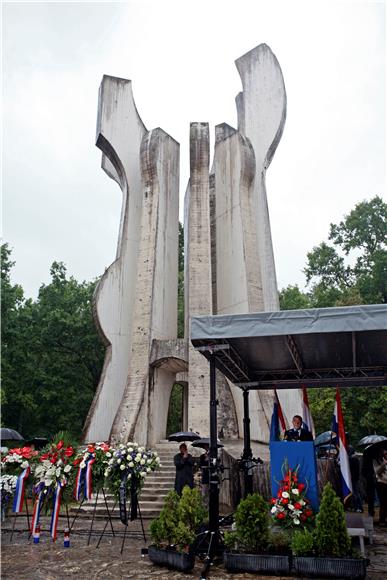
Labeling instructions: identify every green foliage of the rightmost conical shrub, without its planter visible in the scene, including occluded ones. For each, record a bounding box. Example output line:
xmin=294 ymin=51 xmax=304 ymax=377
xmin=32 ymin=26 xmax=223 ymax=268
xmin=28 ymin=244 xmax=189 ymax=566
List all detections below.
xmin=314 ymin=483 xmax=351 ymax=557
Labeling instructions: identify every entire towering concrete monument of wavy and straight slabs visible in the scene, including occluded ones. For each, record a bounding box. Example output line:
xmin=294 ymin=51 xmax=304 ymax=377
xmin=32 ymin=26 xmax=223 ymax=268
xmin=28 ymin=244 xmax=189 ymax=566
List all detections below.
xmin=84 ymin=44 xmax=300 ymax=445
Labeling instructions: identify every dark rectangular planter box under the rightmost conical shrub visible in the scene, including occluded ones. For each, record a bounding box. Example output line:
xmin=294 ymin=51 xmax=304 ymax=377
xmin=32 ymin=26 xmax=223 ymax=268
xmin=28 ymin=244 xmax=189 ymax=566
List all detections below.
xmin=292 ymin=556 xmax=368 ymax=580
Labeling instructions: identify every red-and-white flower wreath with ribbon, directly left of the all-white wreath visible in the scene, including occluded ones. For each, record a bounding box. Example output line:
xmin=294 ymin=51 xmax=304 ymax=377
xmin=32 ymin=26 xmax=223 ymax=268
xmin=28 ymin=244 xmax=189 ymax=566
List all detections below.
xmin=73 ymin=442 xmax=113 ymax=501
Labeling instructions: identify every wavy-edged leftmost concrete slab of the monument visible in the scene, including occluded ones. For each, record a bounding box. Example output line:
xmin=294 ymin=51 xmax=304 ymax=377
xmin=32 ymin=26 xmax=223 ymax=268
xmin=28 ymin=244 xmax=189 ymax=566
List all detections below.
xmin=84 ymin=76 xmax=147 ymax=441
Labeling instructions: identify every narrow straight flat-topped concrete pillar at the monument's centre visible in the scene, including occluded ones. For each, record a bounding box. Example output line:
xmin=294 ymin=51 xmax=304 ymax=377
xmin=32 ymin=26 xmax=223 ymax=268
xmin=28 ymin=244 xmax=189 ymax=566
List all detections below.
xmin=186 ymin=123 xmax=212 ymax=436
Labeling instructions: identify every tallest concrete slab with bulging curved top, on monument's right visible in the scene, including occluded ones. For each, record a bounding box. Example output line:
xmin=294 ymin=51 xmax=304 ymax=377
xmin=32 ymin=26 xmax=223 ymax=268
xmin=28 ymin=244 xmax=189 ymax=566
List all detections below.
xmin=235 ymin=44 xmax=302 ymax=424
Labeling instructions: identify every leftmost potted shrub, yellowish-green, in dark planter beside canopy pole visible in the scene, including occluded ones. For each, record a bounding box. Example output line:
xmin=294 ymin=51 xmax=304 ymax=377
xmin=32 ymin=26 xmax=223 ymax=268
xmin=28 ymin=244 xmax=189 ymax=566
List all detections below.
xmin=148 ymin=486 xmax=207 ymax=572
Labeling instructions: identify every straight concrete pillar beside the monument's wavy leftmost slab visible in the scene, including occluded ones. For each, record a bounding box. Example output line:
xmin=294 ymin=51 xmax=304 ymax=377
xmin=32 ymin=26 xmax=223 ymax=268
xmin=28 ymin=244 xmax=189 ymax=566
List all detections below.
xmin=111 ymin=129 xmax=179 ymax=442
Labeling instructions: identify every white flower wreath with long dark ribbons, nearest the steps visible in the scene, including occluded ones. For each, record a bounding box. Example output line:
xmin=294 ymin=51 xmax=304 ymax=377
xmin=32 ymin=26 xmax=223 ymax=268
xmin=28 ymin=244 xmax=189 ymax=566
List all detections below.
xmin=105 ymin=442 xmax=161 ymax=525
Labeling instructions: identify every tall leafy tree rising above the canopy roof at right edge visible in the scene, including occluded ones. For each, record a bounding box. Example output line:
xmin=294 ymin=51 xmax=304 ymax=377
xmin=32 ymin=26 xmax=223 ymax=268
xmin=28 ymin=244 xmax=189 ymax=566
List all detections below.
xmin=304 ymin=196 xmax=387 ymax=307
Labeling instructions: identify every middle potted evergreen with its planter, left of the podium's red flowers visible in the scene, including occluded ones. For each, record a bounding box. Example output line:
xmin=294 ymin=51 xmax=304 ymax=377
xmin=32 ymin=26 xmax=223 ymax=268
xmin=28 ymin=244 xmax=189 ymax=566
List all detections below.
xmin=223 ymin=494 xmax=289 ymax=575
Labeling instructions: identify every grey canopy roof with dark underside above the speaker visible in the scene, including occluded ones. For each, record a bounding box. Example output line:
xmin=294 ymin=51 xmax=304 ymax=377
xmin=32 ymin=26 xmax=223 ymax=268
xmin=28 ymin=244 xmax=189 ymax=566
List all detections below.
xmin=191 ymin=304 xmax=387 ymax=389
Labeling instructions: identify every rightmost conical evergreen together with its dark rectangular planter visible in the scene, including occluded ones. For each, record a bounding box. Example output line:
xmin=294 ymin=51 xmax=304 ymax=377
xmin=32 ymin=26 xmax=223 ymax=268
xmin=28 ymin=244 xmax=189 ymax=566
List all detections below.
xmin=291 ymin=483 xmax=366 ymax=579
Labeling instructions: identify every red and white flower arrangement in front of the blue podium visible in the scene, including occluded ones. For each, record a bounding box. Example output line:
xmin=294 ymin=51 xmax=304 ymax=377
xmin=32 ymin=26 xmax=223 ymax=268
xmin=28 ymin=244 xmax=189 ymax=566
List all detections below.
xmin=271 ymin=465 xmax=314 ymax=529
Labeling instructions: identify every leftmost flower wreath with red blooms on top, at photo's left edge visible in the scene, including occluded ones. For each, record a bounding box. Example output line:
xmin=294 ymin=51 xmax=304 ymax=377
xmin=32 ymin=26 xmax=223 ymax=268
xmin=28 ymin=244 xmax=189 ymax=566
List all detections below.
xmin=1 ymin=447 xmax=38 ymax=515
